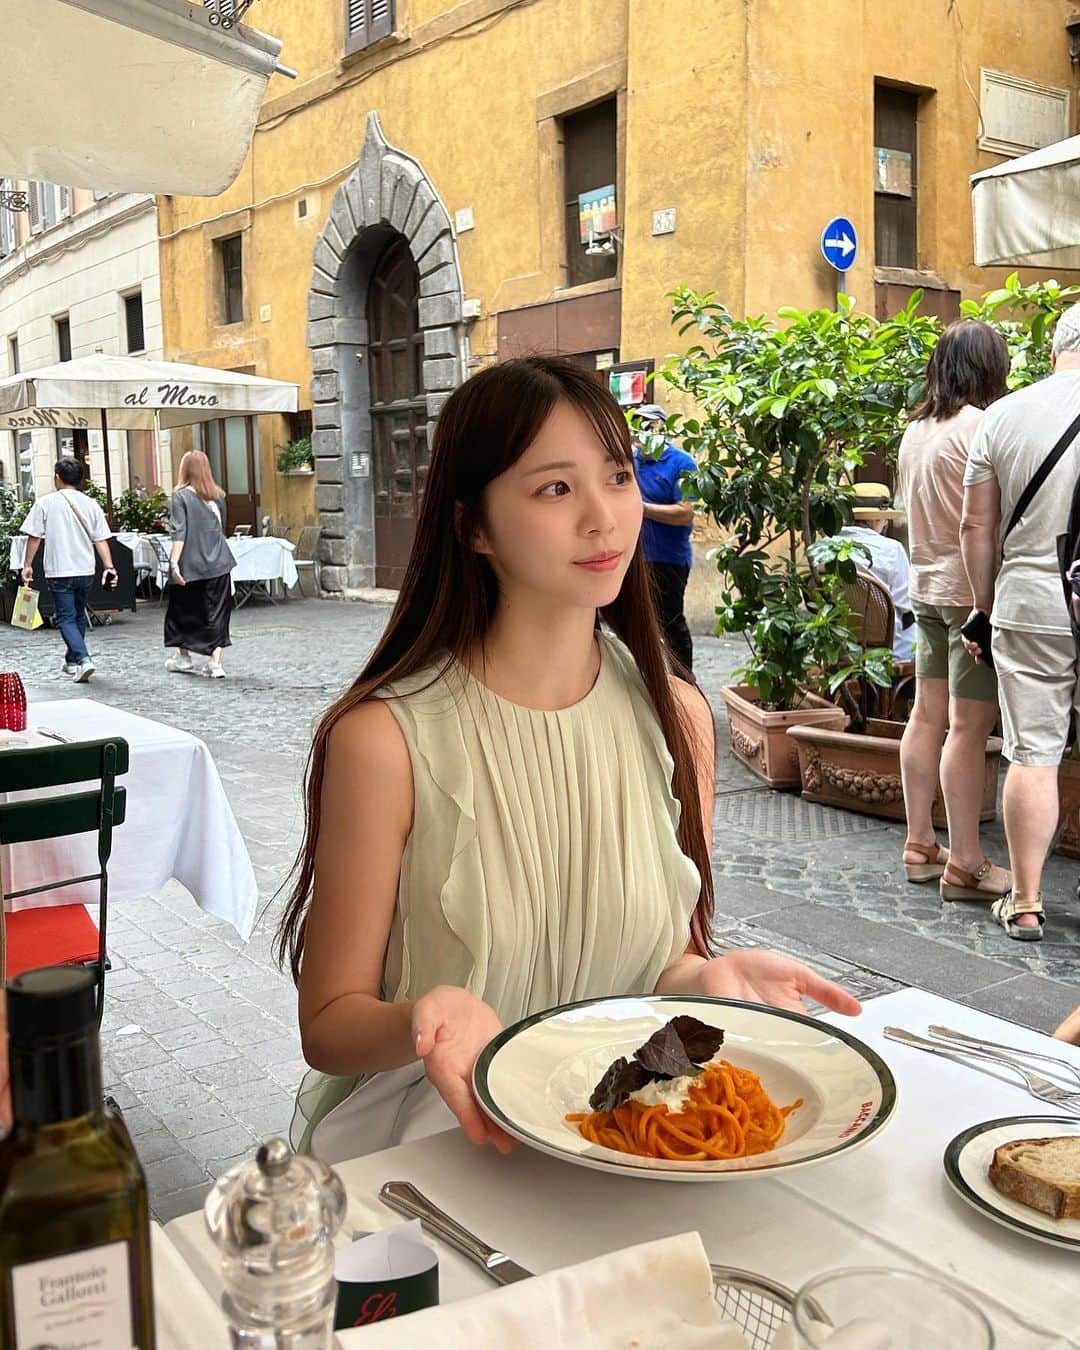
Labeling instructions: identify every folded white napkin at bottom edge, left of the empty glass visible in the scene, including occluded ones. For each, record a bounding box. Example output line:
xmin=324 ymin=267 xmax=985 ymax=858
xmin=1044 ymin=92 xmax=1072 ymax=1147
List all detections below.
xmin=338 ymin=1233 xmax=748 ymax=1350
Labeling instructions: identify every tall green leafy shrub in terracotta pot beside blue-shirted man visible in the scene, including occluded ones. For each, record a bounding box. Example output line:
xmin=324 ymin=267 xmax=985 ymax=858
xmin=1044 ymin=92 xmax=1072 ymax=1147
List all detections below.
xmin=653 ymin=288 xmax=941 ymax=721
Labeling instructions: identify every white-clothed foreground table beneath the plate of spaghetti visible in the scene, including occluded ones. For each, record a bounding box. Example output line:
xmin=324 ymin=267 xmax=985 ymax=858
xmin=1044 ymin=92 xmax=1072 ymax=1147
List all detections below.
xmin=159 ymin=990 xmax=1080 ymax=1350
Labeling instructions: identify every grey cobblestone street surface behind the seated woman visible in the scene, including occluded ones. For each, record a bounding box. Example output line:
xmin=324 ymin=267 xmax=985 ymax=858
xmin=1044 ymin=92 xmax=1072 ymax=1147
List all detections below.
xmin=0 ymin=601 xmax=1080 ymax=1220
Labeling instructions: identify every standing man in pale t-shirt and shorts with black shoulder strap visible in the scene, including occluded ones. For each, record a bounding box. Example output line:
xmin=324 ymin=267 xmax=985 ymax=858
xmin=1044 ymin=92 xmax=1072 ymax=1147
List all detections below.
xmin=960 ymin=305 xmax=1080 ymax=942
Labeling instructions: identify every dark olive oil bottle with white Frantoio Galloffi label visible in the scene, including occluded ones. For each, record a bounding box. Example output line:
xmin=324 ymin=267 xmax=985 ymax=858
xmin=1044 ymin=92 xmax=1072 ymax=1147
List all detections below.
xmin=0 ymin=965 xmax=154 ymax=1350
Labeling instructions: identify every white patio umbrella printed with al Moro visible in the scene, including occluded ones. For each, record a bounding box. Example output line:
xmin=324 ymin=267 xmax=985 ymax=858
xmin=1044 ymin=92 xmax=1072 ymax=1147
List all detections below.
xmin=0 ymin=352 xmax=298 ymax=505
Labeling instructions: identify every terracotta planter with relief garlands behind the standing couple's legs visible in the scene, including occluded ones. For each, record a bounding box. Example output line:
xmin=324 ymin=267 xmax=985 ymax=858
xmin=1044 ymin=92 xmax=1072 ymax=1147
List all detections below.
xmin=787 ymin=718 xmax=1004 ymax=829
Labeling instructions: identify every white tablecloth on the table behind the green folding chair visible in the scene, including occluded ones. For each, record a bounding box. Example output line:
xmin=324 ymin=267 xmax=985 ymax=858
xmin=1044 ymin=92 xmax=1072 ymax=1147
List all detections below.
xmin=0 ymin=698 xmax=258 ymax=938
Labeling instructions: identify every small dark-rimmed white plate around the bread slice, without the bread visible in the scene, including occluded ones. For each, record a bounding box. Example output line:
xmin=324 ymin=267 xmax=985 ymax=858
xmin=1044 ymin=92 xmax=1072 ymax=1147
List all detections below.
xmin=945 ymin=1115 xmax=1080 ymax=1251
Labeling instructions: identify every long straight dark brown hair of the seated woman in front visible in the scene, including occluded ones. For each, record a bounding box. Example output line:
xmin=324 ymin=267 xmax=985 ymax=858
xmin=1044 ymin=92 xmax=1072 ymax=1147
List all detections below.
xmin=275 ymin=356 xmax=713 ymax=980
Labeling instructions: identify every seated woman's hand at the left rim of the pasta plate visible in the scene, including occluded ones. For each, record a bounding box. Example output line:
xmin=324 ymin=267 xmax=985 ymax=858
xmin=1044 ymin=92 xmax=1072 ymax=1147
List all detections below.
xmin=412 ymin=984 xmax=513 ymax=1153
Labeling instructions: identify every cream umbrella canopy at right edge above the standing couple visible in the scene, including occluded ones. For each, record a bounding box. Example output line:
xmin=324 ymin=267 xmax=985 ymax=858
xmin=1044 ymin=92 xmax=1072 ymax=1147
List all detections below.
xmin=971 ymin=136 xmax=1080 ymax=267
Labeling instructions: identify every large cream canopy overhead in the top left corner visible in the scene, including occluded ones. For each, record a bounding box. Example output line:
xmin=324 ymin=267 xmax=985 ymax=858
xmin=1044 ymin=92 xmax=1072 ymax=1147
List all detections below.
xmin=0 ymin=0 xmax=296 ymax=197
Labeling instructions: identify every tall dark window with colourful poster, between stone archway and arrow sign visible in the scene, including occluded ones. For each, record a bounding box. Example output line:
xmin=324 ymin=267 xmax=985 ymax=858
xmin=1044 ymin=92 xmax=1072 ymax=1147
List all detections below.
xmin=562 ymin=99 xmax=618 ymax=286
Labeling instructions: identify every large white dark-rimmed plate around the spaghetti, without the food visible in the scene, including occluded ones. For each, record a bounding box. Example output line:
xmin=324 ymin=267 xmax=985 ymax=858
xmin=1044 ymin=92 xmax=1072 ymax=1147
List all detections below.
xmin=473 ymin=995 xmax=896 ymax=1181
